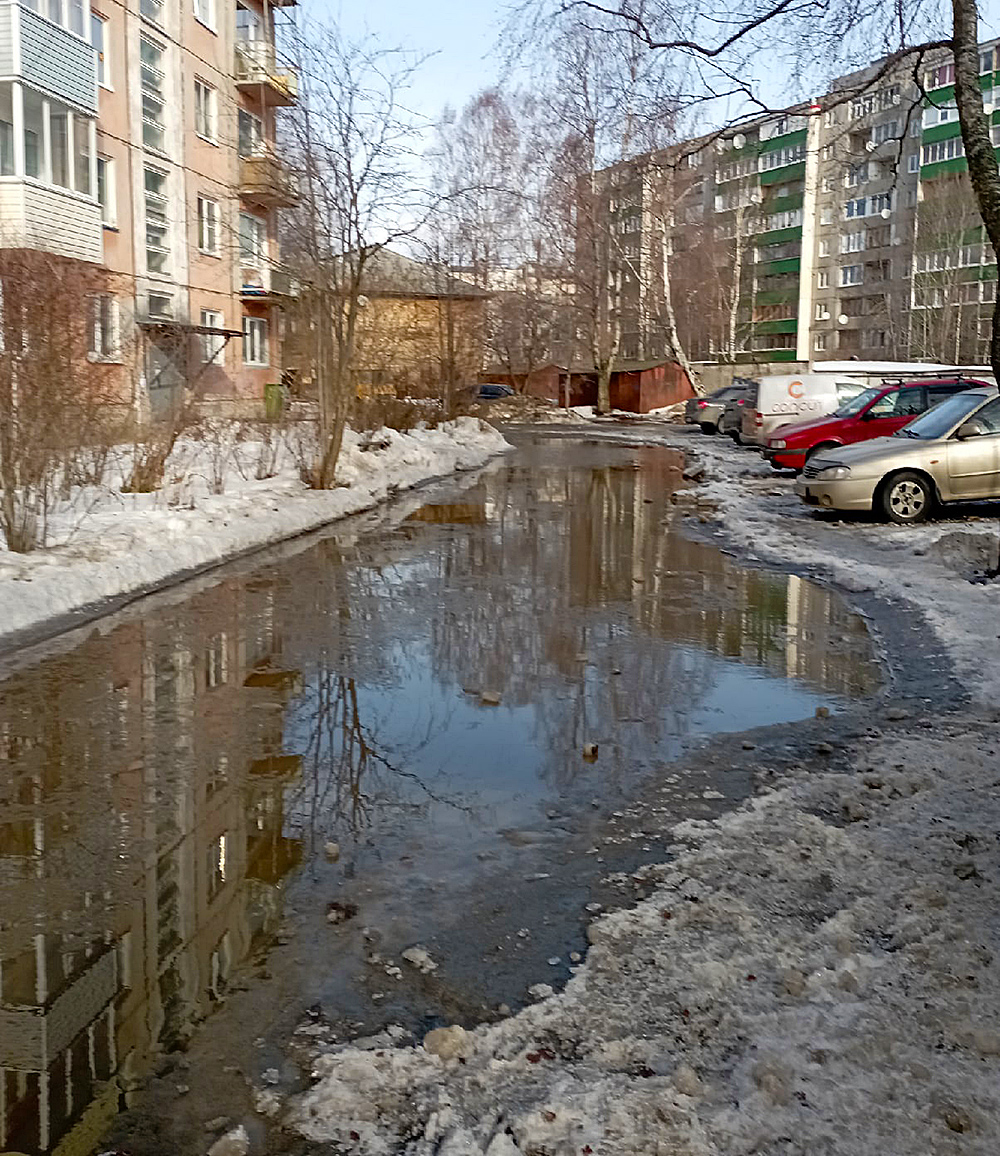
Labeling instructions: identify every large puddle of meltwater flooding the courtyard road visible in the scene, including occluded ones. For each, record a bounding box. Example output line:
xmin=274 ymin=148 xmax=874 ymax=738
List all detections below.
xmin=0 ymin=438 xmax=879 ymax=1156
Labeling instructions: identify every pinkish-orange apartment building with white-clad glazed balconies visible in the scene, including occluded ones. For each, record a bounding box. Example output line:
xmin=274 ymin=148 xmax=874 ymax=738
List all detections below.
xmin=0 ymin=0 xmax=297 ymax=417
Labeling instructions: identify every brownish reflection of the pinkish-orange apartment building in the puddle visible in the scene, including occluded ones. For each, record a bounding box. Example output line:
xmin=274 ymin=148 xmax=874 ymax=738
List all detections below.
xmin=0 ymin=584 xmax=301 ymax=1156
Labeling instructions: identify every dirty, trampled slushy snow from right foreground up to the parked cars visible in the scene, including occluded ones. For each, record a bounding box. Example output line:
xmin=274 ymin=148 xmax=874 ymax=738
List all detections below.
xmin=277 ymin=427 xmax=1000 ymax=1156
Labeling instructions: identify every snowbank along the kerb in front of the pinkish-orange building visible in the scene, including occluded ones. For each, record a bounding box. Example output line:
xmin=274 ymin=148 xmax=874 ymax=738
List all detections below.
xmin=0 ymin=417 xmax=510 ymax=638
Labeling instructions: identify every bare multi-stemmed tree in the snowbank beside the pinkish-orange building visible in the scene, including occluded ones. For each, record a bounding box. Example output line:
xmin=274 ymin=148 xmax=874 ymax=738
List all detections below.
xmin=284 ymin=24 xmax=427 ymax=488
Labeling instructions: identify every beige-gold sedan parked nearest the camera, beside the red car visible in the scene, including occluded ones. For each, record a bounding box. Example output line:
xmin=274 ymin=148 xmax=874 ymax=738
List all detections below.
xmin=795 ymin=386 xmax=1000 ymax=524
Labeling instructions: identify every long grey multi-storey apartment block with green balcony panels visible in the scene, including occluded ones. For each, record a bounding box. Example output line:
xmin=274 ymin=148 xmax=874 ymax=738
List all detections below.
xmin=601 ymin=42 xmax=1000 ymax=366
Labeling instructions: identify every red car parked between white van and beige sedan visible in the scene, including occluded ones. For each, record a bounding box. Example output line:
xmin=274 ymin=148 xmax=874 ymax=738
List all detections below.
xmin=763 ymin=377 xmax=993 ymax=469
